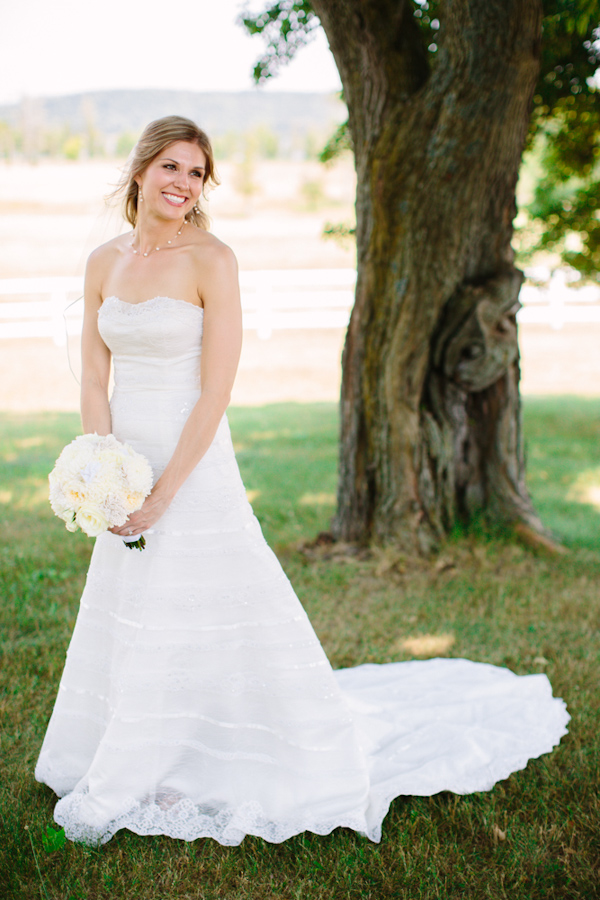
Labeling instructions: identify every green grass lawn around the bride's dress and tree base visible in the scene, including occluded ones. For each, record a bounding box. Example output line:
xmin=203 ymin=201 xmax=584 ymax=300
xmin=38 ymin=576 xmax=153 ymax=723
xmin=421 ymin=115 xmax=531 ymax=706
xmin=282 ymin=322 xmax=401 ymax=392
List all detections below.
xmin=0 ymin=398 xmax=600 ymax=900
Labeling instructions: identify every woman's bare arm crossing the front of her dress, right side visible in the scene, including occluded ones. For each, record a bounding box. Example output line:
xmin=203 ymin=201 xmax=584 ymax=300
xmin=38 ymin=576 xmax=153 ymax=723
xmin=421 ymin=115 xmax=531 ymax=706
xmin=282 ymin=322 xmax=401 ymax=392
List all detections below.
xmin=115 ymin=244 xmax=242 ymax=535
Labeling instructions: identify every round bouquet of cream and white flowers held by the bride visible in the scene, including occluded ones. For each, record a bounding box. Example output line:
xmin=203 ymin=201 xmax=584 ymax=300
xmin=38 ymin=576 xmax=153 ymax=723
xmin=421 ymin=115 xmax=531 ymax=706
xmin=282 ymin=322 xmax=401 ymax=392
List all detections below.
xmin=48 ymin=434 xmax=152 ymax=550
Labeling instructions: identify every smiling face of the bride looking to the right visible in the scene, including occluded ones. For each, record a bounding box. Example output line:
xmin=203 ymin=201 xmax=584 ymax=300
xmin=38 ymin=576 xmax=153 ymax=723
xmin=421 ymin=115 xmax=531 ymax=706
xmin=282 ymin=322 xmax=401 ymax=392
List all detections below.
xmin=135 ymin=141 xmax=206 ymax=219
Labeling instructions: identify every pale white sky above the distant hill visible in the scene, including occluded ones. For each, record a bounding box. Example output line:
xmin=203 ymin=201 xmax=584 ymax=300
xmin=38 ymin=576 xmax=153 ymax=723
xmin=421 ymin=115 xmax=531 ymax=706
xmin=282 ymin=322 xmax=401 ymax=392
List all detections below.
xmin=0 ymin=0 xmax=340 ymax=104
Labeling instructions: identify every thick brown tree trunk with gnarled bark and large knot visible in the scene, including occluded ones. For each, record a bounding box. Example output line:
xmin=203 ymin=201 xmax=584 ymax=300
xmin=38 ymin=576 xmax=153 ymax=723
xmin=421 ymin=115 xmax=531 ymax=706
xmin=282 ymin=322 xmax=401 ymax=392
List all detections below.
xmin=313 ymin=0 xmax=542 ymax=551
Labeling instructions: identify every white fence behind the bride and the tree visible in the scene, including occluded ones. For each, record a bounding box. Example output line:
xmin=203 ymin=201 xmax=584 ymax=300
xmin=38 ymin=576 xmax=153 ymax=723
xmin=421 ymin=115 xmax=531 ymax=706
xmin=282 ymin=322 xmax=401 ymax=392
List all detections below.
xmin=0 ymin=269 xmax=600 ymax=345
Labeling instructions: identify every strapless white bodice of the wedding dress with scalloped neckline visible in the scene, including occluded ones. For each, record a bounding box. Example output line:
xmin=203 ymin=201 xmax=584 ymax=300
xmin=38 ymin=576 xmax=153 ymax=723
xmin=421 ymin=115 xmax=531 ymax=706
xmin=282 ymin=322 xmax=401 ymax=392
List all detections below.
xmin=98 ymin=297 xmax=204 ymax=391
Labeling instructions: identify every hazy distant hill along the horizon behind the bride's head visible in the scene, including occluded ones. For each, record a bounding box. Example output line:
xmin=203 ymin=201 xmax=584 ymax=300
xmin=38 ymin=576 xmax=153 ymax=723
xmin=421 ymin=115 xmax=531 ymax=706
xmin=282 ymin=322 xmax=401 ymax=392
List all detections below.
xmin=0 ymin=90 xmax=346 ymax=143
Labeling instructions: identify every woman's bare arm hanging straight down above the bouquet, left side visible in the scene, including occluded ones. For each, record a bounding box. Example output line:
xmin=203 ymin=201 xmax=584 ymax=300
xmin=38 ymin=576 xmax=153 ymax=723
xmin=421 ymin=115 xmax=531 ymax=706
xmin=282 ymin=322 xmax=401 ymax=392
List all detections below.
xmin=81 ymin=248 xmax=111 ymax=434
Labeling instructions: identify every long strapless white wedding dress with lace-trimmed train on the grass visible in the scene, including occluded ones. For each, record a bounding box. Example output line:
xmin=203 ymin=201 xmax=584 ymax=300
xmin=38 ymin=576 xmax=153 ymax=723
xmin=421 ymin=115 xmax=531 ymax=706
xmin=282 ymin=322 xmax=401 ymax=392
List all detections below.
xmin=36 ymin=297 xmax=569 ymax=844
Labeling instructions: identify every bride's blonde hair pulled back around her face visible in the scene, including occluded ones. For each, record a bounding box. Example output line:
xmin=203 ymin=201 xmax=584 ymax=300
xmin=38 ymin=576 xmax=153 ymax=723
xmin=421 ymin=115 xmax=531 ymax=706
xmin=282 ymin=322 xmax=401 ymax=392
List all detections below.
xmin=108 ymin=116 xmax=220 ymax=230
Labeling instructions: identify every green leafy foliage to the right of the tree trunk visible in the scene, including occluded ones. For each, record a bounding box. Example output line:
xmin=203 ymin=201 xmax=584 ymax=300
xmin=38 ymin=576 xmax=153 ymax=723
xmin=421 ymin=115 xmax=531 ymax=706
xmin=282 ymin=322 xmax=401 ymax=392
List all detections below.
xmin=527 ymin=0 xmax=600 ymax=278
